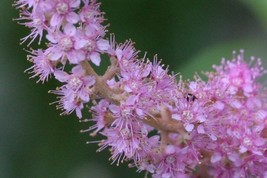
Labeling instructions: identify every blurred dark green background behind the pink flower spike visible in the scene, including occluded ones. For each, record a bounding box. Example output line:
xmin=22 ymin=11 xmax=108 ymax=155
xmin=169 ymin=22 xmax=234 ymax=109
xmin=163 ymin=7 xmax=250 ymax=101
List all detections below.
xmin=0 ymin=0 xmax=267 ymax=178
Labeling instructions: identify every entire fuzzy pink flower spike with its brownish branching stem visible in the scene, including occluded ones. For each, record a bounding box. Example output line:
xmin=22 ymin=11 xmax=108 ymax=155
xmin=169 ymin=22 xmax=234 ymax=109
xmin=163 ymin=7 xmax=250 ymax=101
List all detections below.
xmin=15 ymin=0 xmax=267 ymax=178
